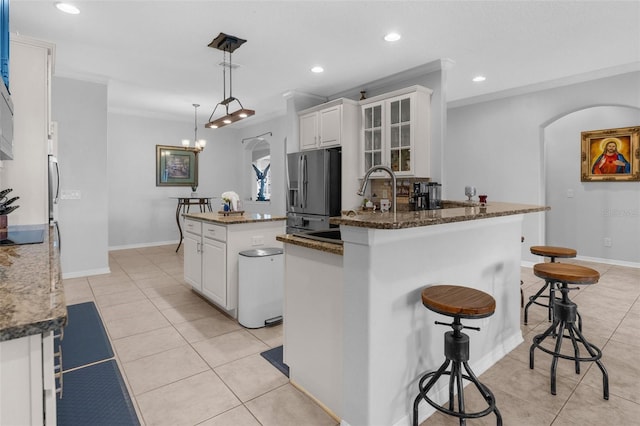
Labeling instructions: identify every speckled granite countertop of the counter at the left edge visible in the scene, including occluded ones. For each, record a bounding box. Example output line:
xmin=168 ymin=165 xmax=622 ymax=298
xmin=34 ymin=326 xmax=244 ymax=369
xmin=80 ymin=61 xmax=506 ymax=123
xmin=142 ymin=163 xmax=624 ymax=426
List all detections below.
xmin=0 ymin=225 xmax=67 ymax=341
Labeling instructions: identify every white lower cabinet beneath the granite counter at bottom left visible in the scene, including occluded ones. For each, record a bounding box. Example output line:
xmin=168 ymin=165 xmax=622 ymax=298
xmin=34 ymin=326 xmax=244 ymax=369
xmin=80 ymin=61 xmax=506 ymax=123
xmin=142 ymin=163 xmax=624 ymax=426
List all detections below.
xmin=0 ymin=332 xmax=56 ymax=426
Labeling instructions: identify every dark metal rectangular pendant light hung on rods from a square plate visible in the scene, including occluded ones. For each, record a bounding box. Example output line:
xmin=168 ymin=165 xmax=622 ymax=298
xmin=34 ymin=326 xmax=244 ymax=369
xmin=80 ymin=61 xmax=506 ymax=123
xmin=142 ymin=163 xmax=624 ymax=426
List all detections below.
xmin=204 ymin=33 xmax=256 ymax=129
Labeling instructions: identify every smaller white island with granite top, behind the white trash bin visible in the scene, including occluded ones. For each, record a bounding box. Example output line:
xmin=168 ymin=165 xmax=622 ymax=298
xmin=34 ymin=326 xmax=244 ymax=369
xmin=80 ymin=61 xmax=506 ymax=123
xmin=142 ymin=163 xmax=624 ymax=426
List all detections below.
xmin=183 ymin=212 xmax=287 ymax=318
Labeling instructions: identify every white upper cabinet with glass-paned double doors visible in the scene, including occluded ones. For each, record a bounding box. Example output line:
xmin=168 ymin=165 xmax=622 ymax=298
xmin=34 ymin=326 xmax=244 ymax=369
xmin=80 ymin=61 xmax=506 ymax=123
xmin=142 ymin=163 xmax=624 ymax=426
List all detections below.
xmin=360 ymin=86 xmax=432 ymax=177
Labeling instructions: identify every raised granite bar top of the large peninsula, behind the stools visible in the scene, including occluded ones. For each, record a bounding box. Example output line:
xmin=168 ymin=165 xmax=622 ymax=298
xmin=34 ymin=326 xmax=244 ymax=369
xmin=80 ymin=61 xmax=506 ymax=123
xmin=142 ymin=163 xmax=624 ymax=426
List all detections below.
xmin=329 ymin=201 xmax=550 ymax=229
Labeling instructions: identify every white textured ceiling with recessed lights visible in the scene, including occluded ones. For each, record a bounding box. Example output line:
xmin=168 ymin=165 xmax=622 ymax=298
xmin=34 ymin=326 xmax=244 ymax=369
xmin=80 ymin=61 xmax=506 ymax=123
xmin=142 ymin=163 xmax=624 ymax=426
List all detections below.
xmin=10 ymin=0 xmax=640 ymax=124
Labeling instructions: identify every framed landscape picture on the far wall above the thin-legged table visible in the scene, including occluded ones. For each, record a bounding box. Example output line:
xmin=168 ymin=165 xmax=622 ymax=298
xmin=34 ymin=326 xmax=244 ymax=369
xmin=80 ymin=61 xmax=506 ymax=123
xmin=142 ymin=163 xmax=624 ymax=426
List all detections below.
xmin=156 ymin=145 xmax=198 ymax=187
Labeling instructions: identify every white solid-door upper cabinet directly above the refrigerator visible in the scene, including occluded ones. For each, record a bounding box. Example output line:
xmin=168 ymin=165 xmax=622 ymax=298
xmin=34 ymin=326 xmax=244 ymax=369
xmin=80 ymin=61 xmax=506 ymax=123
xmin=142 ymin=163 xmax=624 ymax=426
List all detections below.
xmin=298 ymin=99 xmax=358 ymax=151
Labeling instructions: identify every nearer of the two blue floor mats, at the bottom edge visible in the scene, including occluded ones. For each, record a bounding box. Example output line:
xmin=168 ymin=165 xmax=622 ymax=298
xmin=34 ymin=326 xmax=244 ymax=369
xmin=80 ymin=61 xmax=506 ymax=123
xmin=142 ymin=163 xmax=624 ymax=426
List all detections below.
xmin=57 ymin=360 xmax=140 ymax=426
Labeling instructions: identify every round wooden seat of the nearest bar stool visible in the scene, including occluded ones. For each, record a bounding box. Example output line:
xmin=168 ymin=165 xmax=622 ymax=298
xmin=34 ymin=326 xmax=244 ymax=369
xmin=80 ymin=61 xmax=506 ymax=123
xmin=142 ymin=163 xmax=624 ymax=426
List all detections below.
xmin=422 ymin=285 xmax=496 ymax=318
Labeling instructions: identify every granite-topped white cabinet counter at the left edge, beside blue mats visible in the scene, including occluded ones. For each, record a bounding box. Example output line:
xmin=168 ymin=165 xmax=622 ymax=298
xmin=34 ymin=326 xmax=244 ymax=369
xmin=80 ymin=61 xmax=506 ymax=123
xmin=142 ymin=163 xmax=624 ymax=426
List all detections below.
xmin=0 ymin=225 xmax=67 ymax=425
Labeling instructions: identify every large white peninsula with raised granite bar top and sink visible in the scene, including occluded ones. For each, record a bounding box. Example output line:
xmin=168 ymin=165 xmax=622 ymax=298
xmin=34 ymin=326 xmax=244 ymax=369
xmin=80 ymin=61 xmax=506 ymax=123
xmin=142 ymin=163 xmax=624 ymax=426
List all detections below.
xmin=279 ymin=202 xmax=547 ymax=426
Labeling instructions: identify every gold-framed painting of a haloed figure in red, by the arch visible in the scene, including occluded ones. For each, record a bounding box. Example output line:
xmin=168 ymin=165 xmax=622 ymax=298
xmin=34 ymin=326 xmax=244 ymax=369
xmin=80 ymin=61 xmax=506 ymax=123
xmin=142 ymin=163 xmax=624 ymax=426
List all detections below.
xmin=580 ymin=126 xmax=640 ymax=182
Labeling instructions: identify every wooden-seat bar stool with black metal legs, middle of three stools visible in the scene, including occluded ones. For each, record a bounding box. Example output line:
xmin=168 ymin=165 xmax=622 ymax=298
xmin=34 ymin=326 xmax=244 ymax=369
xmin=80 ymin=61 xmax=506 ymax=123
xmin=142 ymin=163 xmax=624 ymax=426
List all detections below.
xmin=529 ymin=263 xmax=609 ymax=399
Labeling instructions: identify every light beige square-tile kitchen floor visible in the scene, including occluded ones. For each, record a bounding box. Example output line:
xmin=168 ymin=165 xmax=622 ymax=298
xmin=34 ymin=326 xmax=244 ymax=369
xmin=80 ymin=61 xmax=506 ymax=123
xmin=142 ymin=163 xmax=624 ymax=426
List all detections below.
xmin=64 ymin=246 xmax=640 ymax=426
